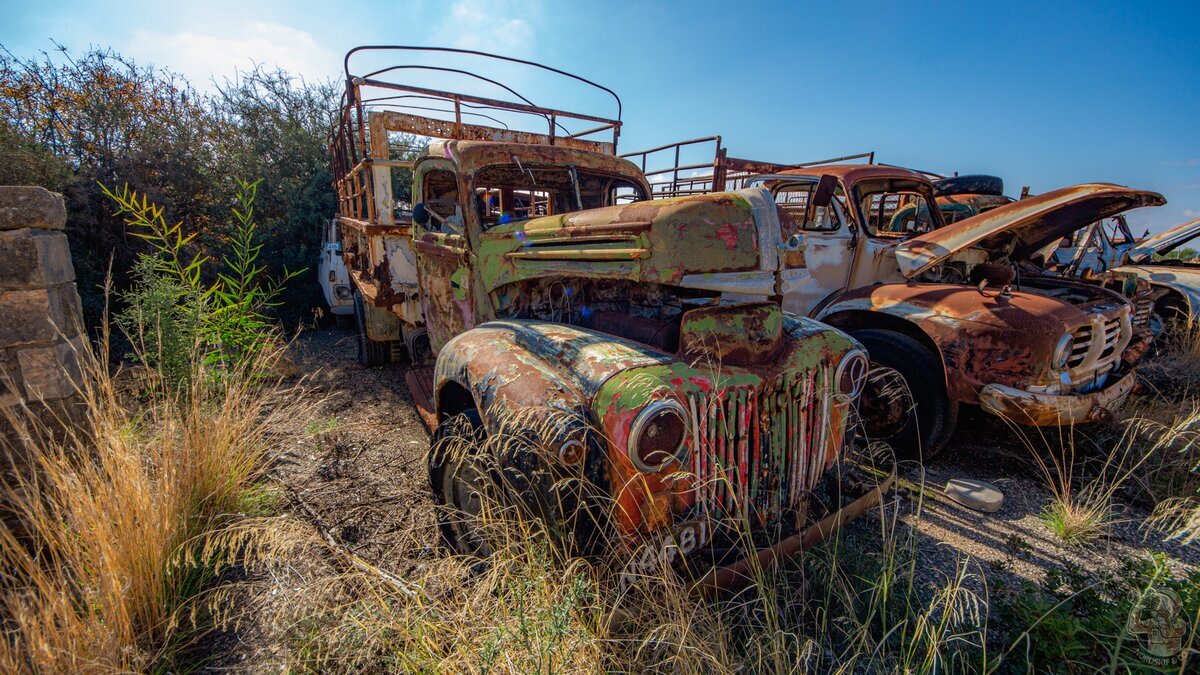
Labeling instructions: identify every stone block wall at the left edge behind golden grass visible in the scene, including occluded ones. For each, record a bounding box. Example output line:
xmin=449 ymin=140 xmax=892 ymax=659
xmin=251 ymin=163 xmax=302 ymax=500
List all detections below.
xmin=0 ymin=186 xmax=86 ymax=415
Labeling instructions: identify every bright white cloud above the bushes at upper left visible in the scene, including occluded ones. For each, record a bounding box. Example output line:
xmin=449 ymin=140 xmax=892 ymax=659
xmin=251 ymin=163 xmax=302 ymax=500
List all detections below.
xmin=127 ymin=22 xmax=331 ymax=89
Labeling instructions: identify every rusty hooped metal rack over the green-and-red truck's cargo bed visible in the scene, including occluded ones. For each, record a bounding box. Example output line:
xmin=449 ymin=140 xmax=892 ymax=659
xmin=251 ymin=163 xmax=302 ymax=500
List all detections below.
xmin=329 ymin=44 xmax=622 ymax=228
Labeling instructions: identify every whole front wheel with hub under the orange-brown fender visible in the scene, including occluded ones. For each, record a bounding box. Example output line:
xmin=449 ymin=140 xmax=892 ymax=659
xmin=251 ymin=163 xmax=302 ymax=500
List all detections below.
xmin=853 ymin=328 xmax=959 ymax=461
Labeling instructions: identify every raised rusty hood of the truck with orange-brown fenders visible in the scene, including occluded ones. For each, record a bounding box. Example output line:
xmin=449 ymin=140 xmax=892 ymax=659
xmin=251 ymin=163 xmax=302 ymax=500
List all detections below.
xmin=895 ymin=183 xmax=1166 ymax=277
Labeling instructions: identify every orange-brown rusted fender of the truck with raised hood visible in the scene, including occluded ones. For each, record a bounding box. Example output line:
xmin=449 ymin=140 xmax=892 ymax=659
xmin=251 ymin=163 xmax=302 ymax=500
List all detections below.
xmin=817 ymin=283 xmax=1090 ymax=404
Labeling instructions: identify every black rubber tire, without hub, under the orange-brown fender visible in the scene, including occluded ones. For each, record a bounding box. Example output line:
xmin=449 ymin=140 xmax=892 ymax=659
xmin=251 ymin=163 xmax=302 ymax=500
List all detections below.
xmin=851 ymin=328 xmax=959 ymax=462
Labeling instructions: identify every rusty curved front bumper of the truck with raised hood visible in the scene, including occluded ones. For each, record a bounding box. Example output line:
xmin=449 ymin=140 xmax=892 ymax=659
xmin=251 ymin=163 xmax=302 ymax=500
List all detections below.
xmin=979 ymin=372 xmax=1138 ymax=426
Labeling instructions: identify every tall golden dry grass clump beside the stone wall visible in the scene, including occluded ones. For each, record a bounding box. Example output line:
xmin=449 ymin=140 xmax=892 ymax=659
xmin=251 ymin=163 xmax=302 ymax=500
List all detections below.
xmin=0 ymin=333 xmax=304 ymax=673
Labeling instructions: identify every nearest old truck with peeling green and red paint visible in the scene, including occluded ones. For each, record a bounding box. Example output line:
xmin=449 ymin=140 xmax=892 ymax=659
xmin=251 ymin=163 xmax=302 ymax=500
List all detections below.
xmin=332 ymin=48 xmax=887 ymax=589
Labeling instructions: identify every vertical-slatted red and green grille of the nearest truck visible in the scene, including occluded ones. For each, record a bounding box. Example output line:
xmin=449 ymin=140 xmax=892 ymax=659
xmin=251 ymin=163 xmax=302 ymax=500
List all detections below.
xmin=688 ymin=371 xmax=839 ymax=526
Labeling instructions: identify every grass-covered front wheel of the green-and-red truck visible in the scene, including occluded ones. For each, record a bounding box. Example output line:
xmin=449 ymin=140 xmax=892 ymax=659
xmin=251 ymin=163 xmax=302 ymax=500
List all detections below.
xmin=430 ymin=408 xmax=497 ymax=557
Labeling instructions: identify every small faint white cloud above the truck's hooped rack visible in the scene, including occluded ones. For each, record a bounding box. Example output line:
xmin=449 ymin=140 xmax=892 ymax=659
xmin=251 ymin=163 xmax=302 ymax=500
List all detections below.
xmin=436 ymin=0 xmax=541 ymax=58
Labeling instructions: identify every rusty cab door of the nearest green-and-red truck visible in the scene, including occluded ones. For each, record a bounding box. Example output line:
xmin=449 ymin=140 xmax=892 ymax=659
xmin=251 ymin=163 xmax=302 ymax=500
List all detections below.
xmin=413 ymin=159 xmax=476 ymax=354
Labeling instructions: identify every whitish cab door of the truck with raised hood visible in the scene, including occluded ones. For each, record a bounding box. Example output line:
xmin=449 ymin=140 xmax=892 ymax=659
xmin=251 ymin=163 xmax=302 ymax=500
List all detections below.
xmin=772 ymin=177 xmax=854 ymax=316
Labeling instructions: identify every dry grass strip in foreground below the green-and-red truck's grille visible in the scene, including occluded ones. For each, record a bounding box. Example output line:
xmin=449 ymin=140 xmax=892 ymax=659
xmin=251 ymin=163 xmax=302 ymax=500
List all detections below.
xmin=267 ymin=413 xmax=988 ymax=674
